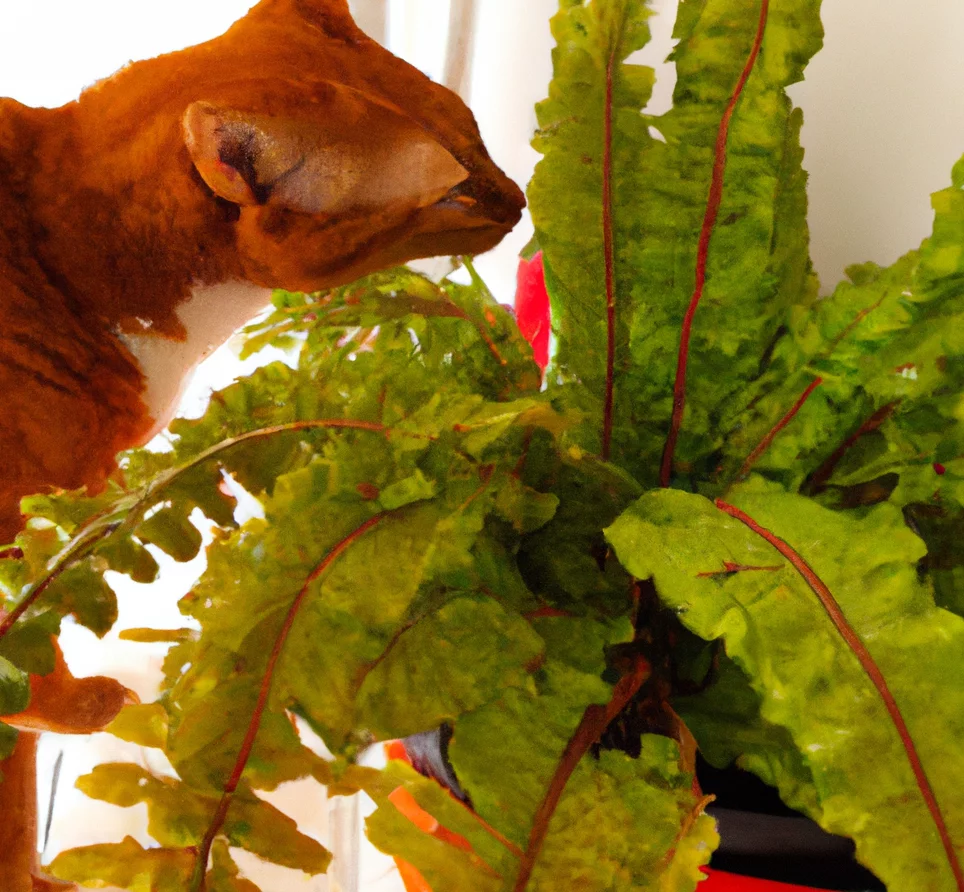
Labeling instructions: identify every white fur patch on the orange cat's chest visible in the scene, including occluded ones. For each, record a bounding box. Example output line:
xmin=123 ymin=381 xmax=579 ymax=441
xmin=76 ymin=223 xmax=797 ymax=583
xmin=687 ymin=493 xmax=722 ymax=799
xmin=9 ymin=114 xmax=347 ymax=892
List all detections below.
xmin=120 ymin=282 xmax=271 ymax=439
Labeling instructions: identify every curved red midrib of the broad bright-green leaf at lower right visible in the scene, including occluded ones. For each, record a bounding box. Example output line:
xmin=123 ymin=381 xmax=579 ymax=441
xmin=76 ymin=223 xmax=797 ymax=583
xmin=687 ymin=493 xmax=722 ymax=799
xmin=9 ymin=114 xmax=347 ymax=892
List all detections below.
xmin=716 ymin=499 xmax=964 ymax=892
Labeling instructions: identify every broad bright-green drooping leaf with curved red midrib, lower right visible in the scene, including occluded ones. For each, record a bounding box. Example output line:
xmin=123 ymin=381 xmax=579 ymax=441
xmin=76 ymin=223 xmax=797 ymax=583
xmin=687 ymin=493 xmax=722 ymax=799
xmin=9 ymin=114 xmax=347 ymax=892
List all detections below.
xmin=607 ymin=487 xmax=964 ymax=892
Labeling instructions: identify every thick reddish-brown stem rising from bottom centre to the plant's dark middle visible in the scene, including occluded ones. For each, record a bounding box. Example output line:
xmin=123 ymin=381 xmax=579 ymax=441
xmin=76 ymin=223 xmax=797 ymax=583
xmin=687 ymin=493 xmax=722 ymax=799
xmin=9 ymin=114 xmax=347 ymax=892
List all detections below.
xmin=512 ymin=657 xmax=649 ymax=892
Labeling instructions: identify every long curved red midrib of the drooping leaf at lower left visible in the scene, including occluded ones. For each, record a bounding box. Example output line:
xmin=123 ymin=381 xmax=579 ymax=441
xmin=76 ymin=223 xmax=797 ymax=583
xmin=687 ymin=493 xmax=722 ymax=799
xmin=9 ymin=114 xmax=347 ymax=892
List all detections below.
xmin=191 ymin=512 xmax=388 ymax=892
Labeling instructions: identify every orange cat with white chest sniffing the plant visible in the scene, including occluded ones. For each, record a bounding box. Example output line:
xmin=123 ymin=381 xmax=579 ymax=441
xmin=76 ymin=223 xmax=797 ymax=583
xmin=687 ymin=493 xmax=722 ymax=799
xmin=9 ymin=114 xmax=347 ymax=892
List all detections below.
xmin=0 ymin=0 xmax=523 ymax=892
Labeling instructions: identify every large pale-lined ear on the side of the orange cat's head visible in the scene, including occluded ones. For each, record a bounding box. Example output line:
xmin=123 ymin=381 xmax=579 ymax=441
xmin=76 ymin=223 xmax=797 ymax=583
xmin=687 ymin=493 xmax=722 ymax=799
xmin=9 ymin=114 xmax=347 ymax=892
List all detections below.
xmin=183 ymin=98 xmax=468 ymax=216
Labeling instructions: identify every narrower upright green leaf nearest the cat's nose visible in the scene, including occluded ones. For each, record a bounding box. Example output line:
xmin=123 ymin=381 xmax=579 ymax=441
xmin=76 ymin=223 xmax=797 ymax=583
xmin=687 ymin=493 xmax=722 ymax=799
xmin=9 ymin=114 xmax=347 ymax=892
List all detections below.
xmin=528 ymin=0 xmax=653 ymax=460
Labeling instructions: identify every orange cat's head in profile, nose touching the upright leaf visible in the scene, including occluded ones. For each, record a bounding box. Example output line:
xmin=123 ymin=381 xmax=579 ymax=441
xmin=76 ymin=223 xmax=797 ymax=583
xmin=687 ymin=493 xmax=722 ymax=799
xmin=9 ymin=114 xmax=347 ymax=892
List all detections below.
xmin=176 ymin=0 xmax=524 ymax=290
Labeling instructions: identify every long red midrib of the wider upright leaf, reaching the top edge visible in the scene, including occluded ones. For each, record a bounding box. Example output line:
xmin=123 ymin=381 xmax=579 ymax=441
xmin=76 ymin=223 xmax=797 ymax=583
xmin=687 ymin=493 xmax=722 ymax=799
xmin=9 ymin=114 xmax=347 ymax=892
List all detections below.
xmin=659 ymin=0 xmax=770 ymax=487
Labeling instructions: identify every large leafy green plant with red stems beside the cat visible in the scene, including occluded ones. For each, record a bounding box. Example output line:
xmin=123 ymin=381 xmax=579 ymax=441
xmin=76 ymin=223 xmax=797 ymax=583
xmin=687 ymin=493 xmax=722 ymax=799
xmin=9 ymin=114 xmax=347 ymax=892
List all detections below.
xmin=0 ymin=0 xmax=964 ymax=892
